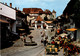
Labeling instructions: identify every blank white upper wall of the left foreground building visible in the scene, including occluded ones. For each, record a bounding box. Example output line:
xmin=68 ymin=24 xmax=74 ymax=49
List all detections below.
xmin=0 ymin=3 xmax=16 ymax=20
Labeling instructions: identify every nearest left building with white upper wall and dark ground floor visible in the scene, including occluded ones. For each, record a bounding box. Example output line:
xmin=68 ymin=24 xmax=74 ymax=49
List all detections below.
xmin=0 ymin=2 xmax=16 ymax=48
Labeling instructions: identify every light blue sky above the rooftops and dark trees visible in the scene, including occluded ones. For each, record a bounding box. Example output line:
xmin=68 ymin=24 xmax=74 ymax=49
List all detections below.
xmin=0 ymin=0 xmax=70 ymax=16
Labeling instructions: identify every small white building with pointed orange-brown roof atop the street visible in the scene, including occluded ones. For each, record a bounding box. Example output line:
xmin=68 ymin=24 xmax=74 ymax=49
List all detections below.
xmin=33 ymin=16 xmax=54 ymax=29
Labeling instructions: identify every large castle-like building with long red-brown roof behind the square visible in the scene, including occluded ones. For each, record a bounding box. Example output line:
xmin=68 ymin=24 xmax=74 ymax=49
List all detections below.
xmin=23 ymin=8 xmax=56 ymax=26
